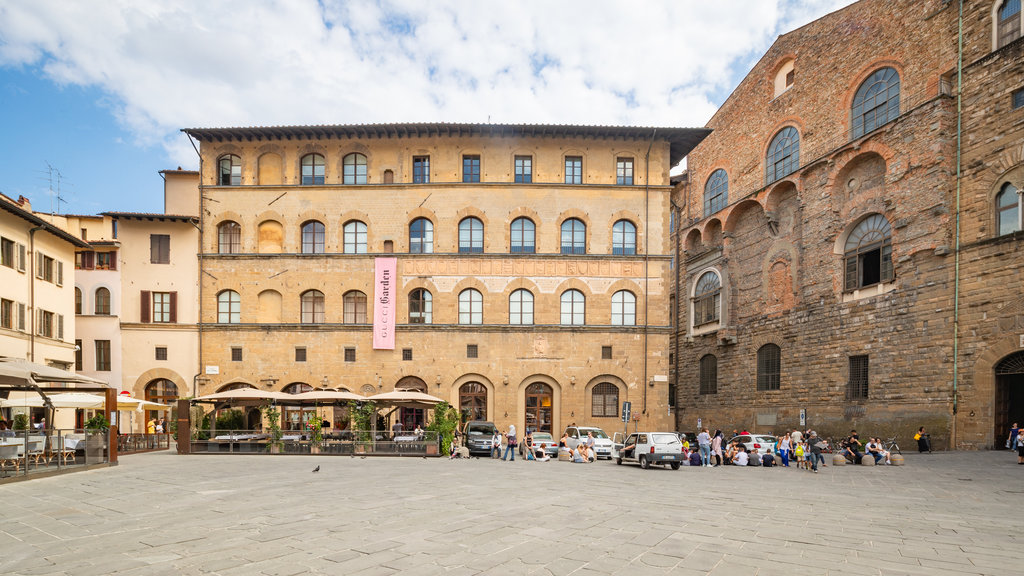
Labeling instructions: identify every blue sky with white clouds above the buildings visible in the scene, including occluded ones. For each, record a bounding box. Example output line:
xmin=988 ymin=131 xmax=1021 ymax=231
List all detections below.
xmin=0 ymin=0 xmax=851 ymax=214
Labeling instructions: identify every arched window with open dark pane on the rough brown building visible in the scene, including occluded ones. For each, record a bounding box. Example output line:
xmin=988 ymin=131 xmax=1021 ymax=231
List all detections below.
xmin=844 ymin=214 xmax=893 ymax=291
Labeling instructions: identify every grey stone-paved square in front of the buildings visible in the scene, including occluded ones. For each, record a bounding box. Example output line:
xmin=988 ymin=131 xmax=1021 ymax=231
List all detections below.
xmin=0 ymin=452 xmax=1024 ymax=576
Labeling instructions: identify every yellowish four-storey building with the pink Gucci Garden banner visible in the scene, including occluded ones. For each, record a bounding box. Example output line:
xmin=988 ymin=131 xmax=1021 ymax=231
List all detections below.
xmin=185 ymin=124 xmax=707 ymax=434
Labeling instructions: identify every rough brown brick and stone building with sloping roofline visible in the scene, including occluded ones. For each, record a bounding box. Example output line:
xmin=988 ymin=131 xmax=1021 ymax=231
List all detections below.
xmin=671 ymin=0 xmax=1024 ymax=447
